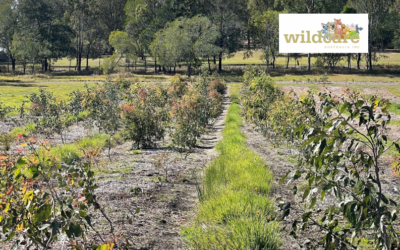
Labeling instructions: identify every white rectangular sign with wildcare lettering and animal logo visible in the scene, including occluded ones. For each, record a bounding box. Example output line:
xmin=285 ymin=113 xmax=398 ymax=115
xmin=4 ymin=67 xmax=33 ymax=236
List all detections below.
xmin=279 ymin=14 xmax=368 ymax=53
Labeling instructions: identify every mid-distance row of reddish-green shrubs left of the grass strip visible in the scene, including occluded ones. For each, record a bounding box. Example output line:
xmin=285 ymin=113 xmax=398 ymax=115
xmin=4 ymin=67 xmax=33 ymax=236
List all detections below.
xmin=1 ymin=75 xmax=226 ymax=153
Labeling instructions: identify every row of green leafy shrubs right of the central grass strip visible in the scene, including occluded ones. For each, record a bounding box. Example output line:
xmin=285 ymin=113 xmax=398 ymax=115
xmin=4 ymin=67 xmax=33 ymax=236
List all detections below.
xmin=241 ymin=68 xmax=400 ymax=249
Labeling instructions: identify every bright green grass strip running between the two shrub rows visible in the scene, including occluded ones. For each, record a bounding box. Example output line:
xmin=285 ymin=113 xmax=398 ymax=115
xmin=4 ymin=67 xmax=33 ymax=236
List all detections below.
xmin=182 ymin=86 xmax=281 ymax=249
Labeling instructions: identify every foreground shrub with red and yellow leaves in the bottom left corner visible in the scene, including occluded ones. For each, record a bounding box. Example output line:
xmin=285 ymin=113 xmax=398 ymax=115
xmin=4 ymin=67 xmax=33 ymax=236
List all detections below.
xmin=0 ymin=139 xmax=109 ymax=249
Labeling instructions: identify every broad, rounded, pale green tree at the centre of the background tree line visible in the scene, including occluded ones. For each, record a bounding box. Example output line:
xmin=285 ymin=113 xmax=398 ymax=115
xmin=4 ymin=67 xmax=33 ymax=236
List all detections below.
xmin=150 ymin=16 xmax=219 ymax=76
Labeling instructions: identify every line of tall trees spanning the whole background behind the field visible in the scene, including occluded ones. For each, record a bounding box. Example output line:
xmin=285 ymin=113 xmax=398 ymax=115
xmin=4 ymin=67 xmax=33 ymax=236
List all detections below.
xmin=0 ymin=0 xmax=400 ymax=75
